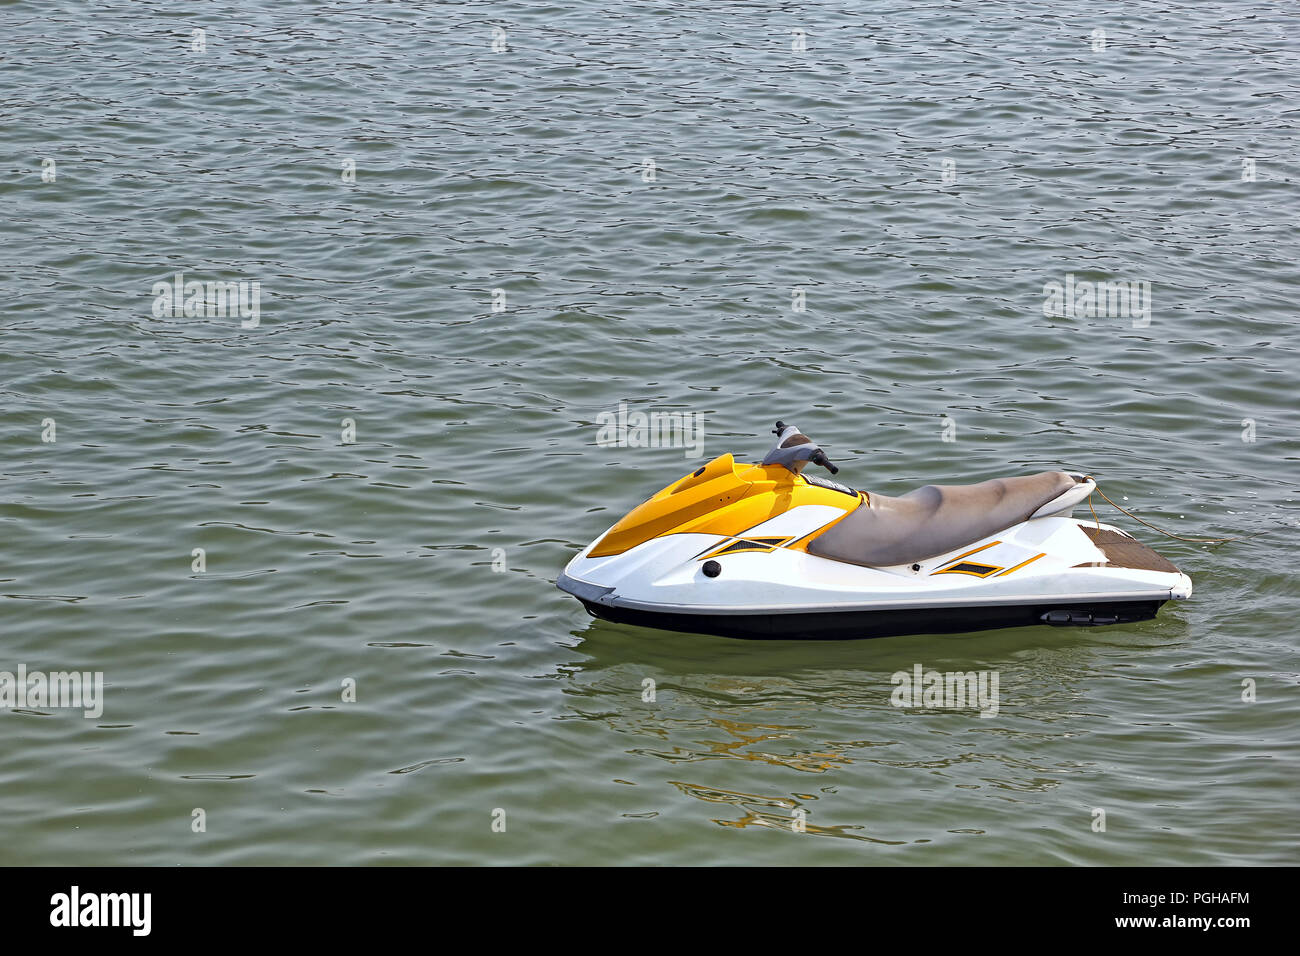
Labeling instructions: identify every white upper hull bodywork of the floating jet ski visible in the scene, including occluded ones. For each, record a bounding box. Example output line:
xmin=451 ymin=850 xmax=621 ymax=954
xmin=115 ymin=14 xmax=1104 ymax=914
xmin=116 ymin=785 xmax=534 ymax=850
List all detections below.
xmin=559 ymin=506 xmax=1192 ymax=630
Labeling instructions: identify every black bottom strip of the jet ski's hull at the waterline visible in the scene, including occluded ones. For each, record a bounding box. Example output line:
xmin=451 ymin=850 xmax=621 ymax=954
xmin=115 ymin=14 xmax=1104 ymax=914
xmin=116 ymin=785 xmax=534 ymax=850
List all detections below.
xmin=582 ymin=601 xmax=1165 ymax=640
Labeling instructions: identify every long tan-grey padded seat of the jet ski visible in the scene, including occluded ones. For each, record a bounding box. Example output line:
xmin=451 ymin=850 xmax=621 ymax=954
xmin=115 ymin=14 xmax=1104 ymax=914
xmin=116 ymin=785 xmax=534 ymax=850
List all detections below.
xmin=809 ymin=471 xmax=1075 ymax=567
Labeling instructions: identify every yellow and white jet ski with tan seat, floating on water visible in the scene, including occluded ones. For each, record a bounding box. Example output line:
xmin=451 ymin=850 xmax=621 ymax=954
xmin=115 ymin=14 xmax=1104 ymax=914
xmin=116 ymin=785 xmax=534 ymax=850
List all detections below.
xmin=556 ymin=421 xmax=1192 ymax=639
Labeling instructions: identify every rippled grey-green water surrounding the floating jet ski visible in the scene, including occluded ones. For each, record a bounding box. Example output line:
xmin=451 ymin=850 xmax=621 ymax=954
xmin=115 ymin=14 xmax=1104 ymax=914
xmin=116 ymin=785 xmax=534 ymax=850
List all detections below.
xmin=0 ymin=0 xmax=1300 ymax=865
